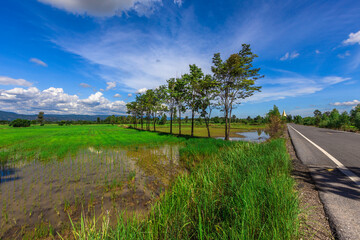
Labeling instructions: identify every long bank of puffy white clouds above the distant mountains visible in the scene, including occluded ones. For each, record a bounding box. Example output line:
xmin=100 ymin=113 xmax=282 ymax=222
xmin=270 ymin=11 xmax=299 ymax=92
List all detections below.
xmin=0 ymin=87 xmax=126 ymax=114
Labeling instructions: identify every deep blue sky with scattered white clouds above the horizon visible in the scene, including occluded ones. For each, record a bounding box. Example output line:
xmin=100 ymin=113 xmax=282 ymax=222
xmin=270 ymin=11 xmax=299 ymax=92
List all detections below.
xmin=0 ymin=0 xmax=360 ymax=117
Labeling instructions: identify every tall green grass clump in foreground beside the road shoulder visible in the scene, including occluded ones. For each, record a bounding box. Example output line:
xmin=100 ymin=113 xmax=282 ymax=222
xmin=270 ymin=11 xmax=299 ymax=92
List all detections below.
xmin=67 ymin=139 xmax=299 ymax=239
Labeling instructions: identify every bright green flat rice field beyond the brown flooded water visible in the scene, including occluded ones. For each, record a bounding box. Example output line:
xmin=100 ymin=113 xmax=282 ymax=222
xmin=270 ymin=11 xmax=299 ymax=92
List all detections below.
xmin=0 ymin=124 xmax=264 ymax=162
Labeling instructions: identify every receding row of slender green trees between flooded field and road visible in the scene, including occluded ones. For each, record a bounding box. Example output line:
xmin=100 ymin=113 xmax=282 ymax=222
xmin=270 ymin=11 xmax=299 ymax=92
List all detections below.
xmin=126 ymin=44 xmax=263 ymax=140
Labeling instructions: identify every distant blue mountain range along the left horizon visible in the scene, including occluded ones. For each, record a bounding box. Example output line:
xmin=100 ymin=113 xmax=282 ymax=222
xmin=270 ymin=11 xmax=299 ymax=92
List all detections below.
xmin=0 ymin=111 xmax=119 ymax=121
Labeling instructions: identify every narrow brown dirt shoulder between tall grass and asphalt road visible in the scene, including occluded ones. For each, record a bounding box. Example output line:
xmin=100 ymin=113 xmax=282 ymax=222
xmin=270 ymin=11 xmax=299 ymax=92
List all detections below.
xmin=285 ymin=130 xmax=335 ymax=240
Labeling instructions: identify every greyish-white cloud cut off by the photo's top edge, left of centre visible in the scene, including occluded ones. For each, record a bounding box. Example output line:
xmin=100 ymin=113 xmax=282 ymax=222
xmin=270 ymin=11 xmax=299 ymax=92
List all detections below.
xmin=38 ymin=0 xmax=161 ymax=17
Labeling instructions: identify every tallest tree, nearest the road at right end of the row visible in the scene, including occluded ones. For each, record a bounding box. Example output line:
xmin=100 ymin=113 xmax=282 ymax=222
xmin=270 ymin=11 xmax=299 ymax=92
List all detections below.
xmin=211 ymin=44 xmax=263 ymax=140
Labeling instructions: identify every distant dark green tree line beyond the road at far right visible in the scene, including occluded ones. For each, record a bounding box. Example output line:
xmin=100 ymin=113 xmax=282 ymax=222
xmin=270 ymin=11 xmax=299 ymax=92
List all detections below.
xmin=293 ymin=104 xmax=360 ymax=130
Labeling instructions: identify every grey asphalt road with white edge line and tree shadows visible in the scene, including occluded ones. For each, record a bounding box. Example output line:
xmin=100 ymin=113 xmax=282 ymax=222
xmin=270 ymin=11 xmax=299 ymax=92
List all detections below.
xmin=288 ymin=124 xmax=360 ymax=240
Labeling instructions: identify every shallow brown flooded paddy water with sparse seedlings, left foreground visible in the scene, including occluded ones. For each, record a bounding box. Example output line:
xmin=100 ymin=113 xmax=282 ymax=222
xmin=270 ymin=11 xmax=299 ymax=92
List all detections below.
xmin=0 ymin=145 xmax=183 ymax=239
